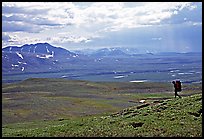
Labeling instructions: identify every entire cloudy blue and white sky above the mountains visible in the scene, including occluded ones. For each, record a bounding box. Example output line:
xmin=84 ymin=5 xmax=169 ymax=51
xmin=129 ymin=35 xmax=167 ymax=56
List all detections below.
xmin=2 ymin=2 xmax=202 ymax=52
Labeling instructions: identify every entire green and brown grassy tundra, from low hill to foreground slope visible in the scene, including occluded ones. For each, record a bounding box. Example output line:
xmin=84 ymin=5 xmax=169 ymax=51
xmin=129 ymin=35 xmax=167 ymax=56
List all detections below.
xmin=2 ymin=79 xmax=202 ymax=136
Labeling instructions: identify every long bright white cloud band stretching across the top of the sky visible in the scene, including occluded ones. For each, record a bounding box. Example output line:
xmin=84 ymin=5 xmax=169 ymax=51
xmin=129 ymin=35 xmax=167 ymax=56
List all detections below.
xmin=2 ymin=2 xmax=196 ymax=31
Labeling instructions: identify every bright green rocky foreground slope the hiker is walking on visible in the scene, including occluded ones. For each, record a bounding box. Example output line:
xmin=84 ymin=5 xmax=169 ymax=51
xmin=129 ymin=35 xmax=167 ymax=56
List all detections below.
xmin=2 ymin=93 xmax=202 ymax=137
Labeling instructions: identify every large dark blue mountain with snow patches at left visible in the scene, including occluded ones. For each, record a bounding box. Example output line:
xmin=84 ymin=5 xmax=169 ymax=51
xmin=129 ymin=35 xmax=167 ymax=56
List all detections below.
xmin=2 ymin=43 xmax=80 ymax=73
